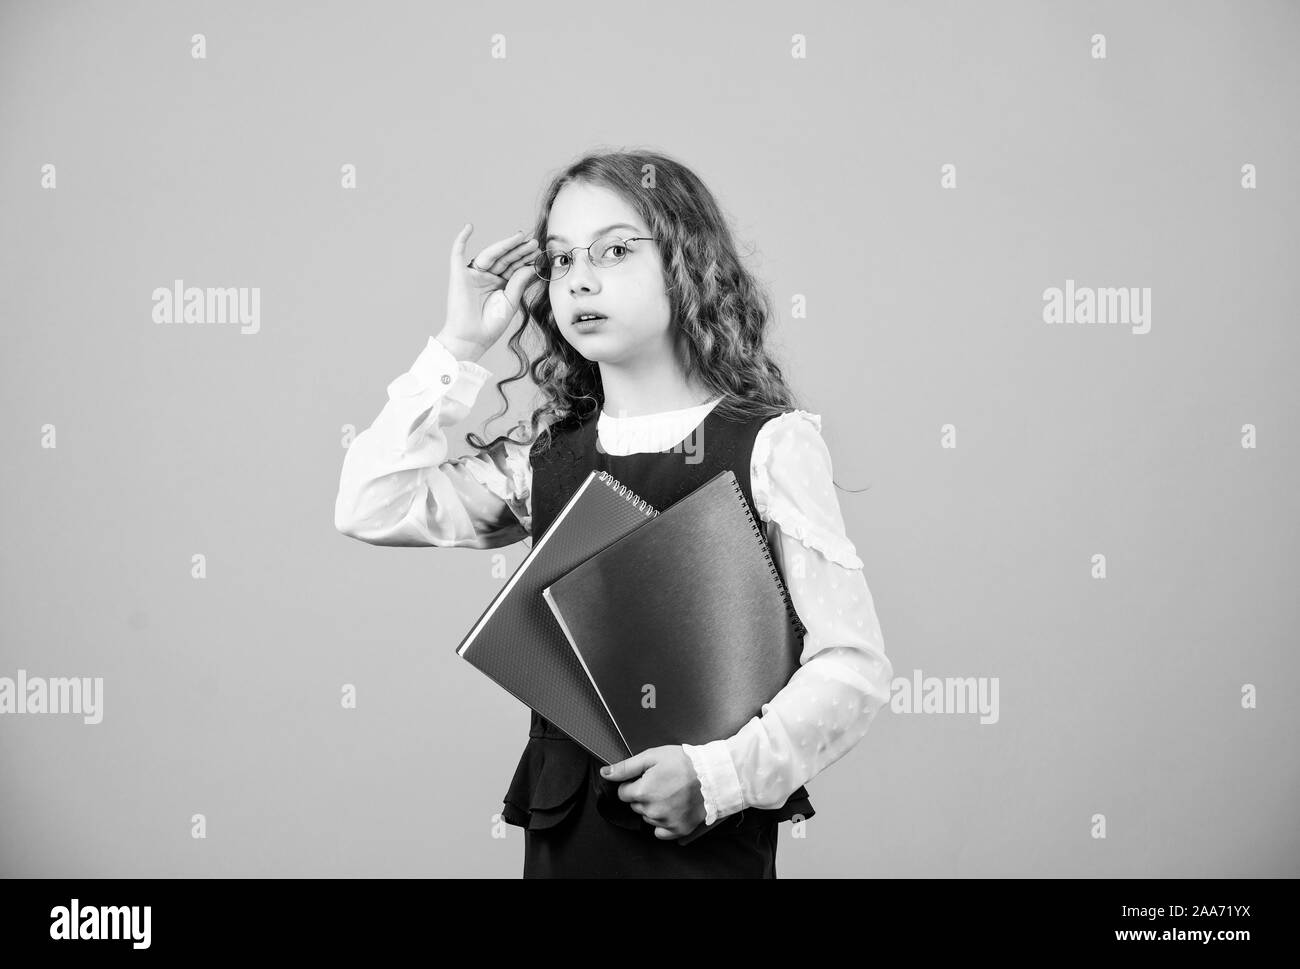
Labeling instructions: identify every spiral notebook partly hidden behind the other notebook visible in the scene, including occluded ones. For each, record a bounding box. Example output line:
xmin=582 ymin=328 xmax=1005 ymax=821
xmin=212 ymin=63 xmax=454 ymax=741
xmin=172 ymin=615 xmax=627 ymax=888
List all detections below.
xmin=456 ymin=471 xmax=659 ymax=763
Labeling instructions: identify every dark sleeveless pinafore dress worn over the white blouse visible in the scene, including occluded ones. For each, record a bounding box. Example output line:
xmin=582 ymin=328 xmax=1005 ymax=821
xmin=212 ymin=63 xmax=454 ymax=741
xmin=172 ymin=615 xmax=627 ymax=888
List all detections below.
xmin=502 ymin=408 xmax=814 ymax=878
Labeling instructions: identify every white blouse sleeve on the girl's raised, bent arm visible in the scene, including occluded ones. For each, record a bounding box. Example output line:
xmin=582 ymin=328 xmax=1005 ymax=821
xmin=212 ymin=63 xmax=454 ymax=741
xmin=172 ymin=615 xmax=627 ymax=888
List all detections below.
xmin=334 ymin=337 xmax=532 ymax=549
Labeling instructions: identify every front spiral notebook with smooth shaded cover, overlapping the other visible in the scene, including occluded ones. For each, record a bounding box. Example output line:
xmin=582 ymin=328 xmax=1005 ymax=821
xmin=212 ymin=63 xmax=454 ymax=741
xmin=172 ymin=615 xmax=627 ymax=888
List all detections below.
xmin=542 ymin=471 xmax=806 ymax=753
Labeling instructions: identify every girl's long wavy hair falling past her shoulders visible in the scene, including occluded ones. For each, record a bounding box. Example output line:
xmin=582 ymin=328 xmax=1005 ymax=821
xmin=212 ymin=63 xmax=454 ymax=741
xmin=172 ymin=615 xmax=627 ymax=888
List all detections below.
xmin=465 ymin=151 xmax=826 ymax=476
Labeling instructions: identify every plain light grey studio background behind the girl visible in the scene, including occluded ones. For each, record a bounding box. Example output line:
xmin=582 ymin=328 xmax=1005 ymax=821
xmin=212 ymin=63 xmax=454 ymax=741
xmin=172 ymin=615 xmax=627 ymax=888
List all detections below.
xmin=0 ymin=3 xmax=1300 ymax=878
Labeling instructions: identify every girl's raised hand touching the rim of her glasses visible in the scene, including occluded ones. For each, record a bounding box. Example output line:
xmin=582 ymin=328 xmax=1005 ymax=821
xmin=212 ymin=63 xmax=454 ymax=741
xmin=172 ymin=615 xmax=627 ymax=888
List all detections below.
xmin=438 ymin=222 xmax=540 ymax=359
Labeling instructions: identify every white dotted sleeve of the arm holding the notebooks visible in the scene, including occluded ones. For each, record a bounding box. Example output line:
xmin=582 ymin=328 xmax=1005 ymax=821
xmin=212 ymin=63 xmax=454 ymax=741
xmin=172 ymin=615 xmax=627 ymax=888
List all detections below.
xmin=683 ymin=411 xmax=893 ymax=823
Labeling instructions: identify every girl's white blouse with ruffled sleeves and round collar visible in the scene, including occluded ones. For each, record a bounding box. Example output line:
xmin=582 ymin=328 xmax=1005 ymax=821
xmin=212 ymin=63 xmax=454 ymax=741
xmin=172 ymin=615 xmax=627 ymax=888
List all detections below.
xmin=334 ymin=337 xmax=893 ymax=825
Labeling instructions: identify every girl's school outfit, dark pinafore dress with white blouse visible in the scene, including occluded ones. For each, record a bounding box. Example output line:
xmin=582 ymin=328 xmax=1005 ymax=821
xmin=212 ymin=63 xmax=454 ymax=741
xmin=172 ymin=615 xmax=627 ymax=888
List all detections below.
xmin=334 ymin=337 xmax=893 ymax=877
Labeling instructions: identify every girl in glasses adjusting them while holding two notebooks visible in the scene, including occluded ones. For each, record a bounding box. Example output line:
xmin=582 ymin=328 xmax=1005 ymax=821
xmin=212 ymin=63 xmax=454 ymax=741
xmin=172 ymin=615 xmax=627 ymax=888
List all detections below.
xmin=334 ymin=151 xmax=893 ymax=878
